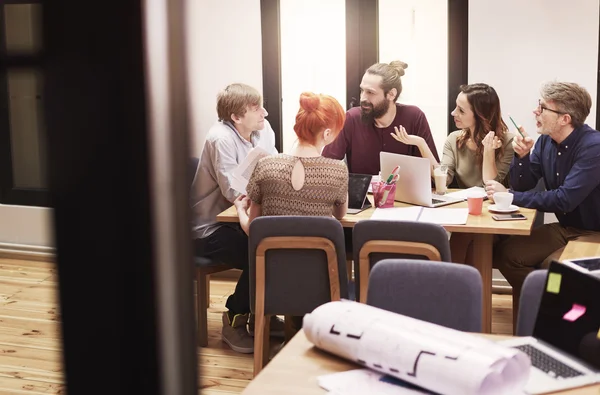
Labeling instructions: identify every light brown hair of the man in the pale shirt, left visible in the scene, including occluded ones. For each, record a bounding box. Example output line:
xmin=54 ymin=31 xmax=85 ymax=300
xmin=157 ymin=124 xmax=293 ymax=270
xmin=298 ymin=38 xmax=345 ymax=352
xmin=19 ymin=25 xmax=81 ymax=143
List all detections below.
xmin=217 ymin=83 xmax=262 ymax=121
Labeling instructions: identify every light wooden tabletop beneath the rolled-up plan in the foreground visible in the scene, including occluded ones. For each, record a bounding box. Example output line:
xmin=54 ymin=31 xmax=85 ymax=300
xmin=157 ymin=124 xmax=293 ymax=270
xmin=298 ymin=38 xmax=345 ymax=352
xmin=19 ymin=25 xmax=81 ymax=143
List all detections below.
xmin=242 ymin=331 xmax=600 ymax=395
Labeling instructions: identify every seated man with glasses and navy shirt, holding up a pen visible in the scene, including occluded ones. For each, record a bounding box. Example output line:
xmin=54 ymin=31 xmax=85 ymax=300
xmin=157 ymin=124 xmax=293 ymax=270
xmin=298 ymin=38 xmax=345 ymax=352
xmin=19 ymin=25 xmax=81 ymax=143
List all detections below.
xmin=486 ymin=82 xmax=600 ymax=326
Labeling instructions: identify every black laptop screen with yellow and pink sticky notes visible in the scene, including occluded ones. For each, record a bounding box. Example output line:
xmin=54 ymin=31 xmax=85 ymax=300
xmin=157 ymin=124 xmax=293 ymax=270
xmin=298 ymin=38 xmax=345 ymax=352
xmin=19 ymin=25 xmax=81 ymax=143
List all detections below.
xmin=533 ymin=261 xmax=600 ymax=369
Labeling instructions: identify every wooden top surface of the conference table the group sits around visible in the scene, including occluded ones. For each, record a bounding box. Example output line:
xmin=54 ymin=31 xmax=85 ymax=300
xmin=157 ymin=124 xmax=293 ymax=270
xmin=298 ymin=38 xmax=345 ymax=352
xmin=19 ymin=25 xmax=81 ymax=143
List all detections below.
xmin=217 ymin=194 xmax=536 ymax=236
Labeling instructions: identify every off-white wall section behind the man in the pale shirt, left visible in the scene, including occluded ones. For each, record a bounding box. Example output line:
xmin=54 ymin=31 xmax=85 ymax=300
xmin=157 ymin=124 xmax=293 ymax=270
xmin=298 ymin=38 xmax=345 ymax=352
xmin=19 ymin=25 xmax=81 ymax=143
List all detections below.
xmin=187 ymin=0 xmax=262 ymax=156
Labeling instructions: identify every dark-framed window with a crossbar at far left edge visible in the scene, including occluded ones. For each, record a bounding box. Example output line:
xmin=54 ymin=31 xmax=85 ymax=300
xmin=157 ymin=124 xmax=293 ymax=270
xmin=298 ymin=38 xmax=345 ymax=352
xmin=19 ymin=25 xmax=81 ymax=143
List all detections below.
xmin=0 ymin=0 xmax=48 ymax=206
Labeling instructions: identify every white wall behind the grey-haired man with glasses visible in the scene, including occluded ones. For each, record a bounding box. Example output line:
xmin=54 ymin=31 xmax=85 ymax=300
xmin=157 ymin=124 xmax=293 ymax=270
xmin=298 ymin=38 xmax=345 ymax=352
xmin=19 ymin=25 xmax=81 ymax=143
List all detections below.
xmin=469 ymin=0 xmax=599 ymax=138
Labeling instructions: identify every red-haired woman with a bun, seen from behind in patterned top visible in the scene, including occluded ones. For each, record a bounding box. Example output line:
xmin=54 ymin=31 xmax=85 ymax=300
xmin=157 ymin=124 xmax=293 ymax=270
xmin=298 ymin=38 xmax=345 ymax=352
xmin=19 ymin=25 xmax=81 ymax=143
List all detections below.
xmin=234 ymin=93 xmax=348 ymax=233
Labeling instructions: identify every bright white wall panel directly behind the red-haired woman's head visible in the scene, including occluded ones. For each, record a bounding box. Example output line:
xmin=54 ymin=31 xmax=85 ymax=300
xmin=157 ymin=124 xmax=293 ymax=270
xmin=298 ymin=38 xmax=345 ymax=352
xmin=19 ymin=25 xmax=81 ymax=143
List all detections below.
xmin=280 ymin=0 xmax=346 ymax=152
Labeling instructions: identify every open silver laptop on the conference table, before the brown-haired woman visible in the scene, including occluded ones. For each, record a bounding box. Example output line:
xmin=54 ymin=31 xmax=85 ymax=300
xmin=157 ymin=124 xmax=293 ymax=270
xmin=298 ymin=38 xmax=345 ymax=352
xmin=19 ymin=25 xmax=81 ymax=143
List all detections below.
xmin=379 ymin=152 xmax=464 ymax=207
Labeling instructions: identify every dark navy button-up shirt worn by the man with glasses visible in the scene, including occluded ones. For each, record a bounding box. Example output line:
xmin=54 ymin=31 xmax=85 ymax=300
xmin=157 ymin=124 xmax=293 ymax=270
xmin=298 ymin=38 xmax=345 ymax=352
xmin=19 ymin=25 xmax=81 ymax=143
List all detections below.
xmin=510 ymin=125 xmax=600 ymax=231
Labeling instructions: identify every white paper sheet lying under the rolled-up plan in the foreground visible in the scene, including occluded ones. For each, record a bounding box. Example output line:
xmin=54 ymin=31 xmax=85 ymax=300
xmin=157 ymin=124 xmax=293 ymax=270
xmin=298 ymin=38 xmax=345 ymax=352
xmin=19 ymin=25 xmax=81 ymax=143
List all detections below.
xmin=317 ymin=369 xmax=433 ymax=395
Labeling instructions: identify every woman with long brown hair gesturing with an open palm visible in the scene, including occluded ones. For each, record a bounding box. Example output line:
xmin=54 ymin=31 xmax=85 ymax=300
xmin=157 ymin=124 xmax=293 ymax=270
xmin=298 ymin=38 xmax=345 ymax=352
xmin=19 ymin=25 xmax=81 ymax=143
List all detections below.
xmin=392 ymin=83 xmax=514 ymax=188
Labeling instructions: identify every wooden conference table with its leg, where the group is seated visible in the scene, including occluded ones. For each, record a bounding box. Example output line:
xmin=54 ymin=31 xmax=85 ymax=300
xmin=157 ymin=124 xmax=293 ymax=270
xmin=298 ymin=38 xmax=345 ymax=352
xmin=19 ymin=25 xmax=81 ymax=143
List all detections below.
xmin=217 ymin=195 xmax=536 ymax=333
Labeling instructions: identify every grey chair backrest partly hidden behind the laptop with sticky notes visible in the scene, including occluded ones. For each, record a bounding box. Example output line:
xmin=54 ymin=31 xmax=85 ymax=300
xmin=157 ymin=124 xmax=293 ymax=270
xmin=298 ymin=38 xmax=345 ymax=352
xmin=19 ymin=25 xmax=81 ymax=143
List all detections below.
xmin=516 ymin=270 xmax=548 ymax=336
